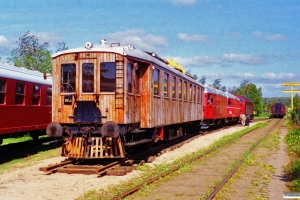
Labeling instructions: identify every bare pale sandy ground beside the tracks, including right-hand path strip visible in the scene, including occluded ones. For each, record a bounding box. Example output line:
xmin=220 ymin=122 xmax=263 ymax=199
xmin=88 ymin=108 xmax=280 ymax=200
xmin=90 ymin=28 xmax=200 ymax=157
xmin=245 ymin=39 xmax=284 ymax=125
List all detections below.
xmin=0 ymin=120 xmax=288 ymax=200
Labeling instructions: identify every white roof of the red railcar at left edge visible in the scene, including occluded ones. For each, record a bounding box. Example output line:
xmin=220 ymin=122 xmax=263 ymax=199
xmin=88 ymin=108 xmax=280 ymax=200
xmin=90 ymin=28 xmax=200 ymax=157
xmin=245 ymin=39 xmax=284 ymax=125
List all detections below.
xmin=0 ymin=61 xmax=52 ymax=85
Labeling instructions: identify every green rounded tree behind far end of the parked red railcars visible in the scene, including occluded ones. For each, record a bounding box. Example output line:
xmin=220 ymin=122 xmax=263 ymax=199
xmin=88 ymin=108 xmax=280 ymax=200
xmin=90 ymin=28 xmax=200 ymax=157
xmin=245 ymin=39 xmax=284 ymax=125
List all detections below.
xmin=235 ymin=80 xmax=263 ymax=115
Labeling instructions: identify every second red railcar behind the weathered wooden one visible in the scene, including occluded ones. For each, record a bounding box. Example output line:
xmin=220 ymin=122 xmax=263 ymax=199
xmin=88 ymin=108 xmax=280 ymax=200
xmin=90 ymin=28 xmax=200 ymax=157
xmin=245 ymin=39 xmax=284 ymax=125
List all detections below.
xmin=225 ymin=92 xmax=241 ymax=123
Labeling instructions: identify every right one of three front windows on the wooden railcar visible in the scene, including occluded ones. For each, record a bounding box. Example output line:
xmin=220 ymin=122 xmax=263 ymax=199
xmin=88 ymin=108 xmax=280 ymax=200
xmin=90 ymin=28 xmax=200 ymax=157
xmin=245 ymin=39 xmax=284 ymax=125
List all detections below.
xmin=100 ymin=62 xmax=116 ymax=92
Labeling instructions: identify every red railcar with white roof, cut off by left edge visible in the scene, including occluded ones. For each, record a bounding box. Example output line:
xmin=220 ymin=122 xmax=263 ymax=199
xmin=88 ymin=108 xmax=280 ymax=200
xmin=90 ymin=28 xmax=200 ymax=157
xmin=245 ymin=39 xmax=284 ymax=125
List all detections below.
xmin=0 ymin=62 xmax=52 ymax=144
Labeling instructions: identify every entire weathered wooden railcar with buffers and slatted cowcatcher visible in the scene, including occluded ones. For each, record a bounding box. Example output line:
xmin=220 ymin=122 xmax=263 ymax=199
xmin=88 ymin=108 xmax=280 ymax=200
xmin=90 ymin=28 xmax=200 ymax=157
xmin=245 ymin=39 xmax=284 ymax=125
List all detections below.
xmin=47 ymin=40 xmax=204 ymax=159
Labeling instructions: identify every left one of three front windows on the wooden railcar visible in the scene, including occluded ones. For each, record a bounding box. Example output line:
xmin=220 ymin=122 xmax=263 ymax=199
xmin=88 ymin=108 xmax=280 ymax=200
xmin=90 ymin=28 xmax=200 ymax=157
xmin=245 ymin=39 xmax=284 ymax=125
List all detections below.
xmin=61 ymin=64 xmax=76 ymax=93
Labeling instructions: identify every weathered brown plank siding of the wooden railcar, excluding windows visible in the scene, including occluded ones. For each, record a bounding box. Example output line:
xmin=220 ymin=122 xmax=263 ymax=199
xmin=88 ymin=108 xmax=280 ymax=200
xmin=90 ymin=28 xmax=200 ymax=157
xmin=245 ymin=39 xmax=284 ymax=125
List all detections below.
xmin=52 ymin=52 xmax=204 ymax=128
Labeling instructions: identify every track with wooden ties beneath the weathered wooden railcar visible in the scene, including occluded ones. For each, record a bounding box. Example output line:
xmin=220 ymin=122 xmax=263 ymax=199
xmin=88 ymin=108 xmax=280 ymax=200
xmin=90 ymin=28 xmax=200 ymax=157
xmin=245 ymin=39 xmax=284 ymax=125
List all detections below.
xmin=39 ymin=119 xmax=265 ymax=176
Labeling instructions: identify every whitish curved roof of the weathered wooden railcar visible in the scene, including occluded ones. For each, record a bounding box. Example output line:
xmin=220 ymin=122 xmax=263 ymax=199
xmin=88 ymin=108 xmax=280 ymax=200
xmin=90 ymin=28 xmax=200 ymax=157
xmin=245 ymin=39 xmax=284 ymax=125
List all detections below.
xmin=52 ymin=43 xmax=204 ymax=87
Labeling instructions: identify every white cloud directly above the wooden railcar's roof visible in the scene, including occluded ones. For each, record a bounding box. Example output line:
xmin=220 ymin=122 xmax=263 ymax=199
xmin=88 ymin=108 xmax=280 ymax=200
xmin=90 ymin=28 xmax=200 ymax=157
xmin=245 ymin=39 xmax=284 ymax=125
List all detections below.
xmin=100 ymin=29 xmax=168 ymax=52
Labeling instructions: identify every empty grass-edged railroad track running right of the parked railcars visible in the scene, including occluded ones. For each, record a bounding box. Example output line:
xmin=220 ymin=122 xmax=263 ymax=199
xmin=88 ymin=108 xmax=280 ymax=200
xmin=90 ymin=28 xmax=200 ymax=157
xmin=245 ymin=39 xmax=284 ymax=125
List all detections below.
xmin=109 ymin=119 xmax=282 ymax=199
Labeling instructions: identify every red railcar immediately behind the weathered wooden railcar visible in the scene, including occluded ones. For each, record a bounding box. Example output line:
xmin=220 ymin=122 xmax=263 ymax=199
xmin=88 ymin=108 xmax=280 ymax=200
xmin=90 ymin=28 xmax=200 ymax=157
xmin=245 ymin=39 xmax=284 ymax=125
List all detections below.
xmin=202 ymin=86 xmax=227 ymax=128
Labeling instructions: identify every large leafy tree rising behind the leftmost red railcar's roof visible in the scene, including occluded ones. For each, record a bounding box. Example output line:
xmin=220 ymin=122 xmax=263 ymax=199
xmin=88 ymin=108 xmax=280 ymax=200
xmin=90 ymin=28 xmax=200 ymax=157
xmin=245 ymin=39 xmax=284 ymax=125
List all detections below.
xmin=8 ymin=31 xmax=52 ymax=73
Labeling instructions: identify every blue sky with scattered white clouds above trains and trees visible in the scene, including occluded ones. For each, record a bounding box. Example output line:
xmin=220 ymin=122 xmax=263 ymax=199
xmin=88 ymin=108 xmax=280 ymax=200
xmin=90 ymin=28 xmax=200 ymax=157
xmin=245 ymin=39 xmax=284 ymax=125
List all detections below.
xmin=0 ymin=0 xmax=300 ymax=97
